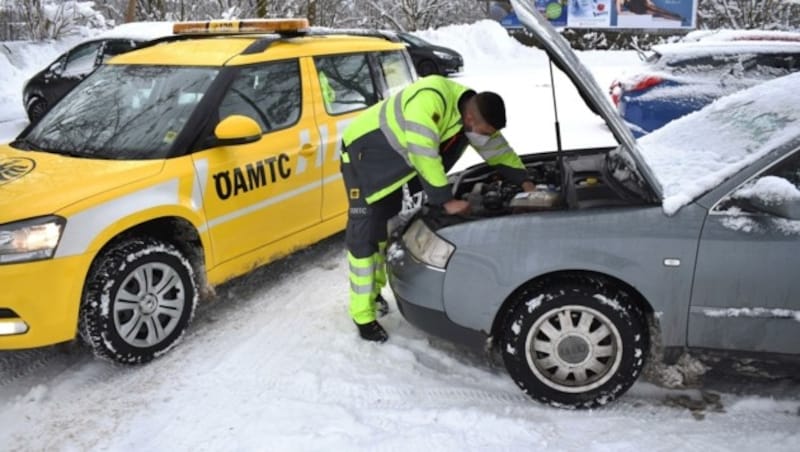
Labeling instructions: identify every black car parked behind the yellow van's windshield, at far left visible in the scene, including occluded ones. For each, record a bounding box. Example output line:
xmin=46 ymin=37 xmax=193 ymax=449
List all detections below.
xmin=22 ymin=38 xmax=145 ymax=122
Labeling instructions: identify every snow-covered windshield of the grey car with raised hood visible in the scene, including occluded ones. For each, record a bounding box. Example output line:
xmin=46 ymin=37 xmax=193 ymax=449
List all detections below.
xmin=639 ymin=73 xmax=800 ymax=214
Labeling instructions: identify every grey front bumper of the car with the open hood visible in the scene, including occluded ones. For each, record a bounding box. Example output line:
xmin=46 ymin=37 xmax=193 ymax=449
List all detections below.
xmin=387 ymin=241 xmax=488 ymax=350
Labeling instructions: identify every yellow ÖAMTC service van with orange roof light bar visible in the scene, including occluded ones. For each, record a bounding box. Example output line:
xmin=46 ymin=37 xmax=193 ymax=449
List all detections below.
xmin=0 ymin=19 xmax=415 ymax=363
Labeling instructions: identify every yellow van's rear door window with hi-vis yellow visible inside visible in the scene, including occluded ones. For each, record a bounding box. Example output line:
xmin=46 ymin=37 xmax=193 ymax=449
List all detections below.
xmin=314 ymin=54 xmax=378 ymax=115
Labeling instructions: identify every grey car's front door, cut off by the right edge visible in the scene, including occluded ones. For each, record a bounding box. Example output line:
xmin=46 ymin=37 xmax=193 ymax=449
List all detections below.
xmin=688 ymin=151 xmax=800 ymax=353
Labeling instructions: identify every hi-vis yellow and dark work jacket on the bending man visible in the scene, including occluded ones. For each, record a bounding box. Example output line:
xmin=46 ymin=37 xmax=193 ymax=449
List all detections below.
xmin=342 ymin=76 xmax=528 ymax=205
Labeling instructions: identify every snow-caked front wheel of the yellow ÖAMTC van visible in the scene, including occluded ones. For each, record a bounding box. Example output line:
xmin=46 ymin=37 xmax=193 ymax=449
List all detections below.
xmin=79 ymin=237 xmax=199 ymax=364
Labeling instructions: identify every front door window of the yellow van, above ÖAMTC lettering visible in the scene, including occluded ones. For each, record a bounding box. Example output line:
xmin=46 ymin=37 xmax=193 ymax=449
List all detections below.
xmin=219 ymin=60 xmax=302 ymax=133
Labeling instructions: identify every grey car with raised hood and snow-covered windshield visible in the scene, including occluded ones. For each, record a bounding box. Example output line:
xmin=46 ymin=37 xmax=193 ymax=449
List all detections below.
xmin=387 ymin=1 xmax=800 ymax=408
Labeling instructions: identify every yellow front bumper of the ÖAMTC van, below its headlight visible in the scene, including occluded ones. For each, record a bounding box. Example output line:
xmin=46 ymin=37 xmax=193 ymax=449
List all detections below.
xmin=0 ymin=256 xmax=88 ymax=350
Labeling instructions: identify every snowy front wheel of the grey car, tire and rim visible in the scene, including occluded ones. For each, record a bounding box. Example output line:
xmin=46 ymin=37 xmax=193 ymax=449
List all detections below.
xmin=501 ymin=277 xmax=649 ymax=408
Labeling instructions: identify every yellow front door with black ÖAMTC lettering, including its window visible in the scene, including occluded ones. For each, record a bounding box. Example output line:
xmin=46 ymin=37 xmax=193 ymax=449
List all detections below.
xmin=193 ymin=59 xmax=322 ymax=263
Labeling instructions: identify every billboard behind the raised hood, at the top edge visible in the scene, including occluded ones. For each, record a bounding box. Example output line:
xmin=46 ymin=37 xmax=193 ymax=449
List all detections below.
xmin=490 ymin=0 xmax=699 ymax=30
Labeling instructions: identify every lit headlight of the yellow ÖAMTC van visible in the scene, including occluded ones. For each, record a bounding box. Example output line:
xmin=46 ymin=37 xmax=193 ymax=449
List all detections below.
xmin=0 ymin=215 xmax=67 ymax=264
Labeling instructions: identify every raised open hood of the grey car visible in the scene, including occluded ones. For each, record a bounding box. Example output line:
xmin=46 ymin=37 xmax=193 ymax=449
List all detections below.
xmin=511 ymin=0 xmax=663 ymax=200
